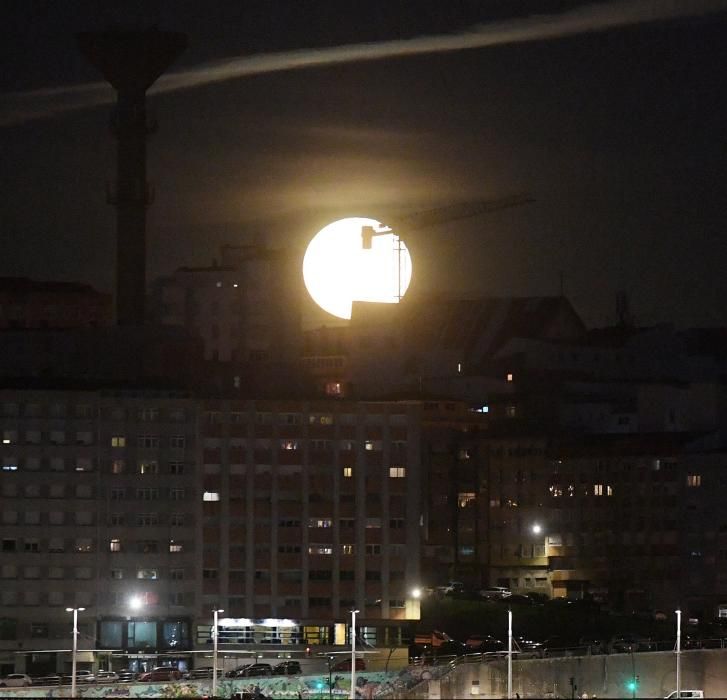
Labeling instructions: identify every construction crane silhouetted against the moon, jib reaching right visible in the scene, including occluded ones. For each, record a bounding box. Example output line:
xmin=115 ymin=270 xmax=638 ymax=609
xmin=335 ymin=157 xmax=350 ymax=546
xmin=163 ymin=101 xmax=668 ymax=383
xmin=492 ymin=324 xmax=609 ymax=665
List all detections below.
xmin=361 ymin=193 xmax=535 ymax=301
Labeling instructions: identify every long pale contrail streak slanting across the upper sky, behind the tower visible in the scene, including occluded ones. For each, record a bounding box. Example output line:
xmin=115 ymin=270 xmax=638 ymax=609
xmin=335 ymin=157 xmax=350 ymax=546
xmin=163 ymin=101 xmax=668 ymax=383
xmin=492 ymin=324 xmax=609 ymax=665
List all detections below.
xmin=0 ymin=0 xmax=727 ymax=126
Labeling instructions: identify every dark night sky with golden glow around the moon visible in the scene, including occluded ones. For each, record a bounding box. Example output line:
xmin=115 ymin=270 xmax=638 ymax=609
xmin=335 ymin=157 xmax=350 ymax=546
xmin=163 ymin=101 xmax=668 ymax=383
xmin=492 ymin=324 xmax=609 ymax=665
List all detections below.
xmin=0 ymin=0 xmax=727 ymax=327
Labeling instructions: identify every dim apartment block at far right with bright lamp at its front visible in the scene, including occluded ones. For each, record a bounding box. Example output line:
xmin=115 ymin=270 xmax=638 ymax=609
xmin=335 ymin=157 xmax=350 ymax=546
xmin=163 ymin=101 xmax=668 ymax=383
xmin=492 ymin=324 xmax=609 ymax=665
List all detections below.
xmin=487 ymin=433 xmax=727 ymax=617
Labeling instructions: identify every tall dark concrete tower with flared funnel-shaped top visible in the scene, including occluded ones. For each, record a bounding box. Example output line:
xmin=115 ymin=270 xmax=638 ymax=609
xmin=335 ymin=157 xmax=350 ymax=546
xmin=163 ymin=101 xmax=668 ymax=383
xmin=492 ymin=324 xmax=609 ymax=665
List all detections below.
xmin=77 ymin=28 xmax=187 ymax=326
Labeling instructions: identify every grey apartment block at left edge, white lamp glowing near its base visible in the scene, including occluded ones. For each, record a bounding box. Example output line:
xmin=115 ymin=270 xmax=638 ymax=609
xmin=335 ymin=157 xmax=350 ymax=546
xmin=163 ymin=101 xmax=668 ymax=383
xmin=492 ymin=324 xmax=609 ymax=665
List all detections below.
xmin=0 ymin=390 xmax=201 ymax=673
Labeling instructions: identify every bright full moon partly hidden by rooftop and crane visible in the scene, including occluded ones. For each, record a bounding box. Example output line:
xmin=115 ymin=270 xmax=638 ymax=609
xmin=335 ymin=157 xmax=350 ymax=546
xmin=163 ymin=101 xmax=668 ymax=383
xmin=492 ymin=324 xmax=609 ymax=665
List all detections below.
xmin=303 ymin=217 xmax=412 ymax=319
